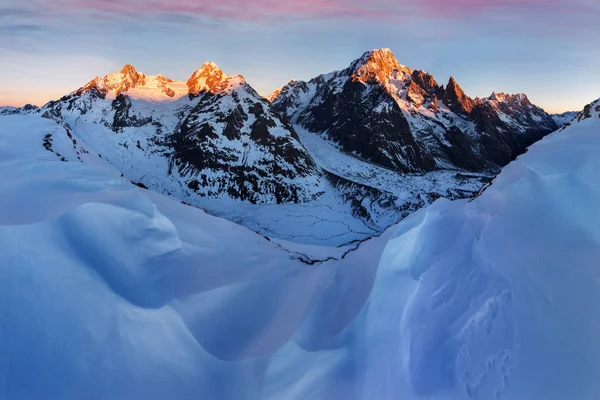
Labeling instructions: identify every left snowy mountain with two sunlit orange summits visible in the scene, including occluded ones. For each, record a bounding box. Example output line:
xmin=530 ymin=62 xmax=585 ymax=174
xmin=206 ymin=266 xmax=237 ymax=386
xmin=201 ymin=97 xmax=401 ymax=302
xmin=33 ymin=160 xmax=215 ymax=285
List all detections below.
xmin=39 ymin=62 xmax=323 ymax=203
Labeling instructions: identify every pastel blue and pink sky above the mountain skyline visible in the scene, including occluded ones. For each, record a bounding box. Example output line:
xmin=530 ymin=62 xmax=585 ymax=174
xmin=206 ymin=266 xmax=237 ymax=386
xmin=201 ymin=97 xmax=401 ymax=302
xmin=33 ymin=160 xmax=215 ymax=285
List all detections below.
xmin=0 ymin=0 xmax=600 ymax=112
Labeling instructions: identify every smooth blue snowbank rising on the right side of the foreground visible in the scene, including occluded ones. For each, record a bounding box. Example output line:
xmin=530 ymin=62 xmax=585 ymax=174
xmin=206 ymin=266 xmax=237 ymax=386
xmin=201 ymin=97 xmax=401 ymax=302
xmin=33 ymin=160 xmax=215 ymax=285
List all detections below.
xmin=365 ymin=104 xmax=600 ymax=399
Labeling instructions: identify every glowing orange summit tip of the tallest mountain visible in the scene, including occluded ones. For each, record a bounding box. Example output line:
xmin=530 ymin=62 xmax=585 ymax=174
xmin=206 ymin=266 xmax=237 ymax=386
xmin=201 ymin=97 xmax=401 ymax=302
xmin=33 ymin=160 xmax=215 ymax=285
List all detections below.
xmin=350 ymin=49 xmax=412 ymax=83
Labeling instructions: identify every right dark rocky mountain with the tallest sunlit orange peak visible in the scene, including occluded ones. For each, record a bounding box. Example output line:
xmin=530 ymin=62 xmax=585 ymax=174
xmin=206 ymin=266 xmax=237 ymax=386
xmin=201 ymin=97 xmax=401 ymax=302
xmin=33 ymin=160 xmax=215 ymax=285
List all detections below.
xmin=272 ymin=49 xmax=558 ymax=172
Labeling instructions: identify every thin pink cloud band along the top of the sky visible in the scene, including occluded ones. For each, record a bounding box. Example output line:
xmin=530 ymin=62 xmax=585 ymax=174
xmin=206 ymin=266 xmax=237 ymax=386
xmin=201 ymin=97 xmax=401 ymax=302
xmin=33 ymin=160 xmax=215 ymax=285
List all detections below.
xmin=50 ymin=0 xmax=592 ymax=21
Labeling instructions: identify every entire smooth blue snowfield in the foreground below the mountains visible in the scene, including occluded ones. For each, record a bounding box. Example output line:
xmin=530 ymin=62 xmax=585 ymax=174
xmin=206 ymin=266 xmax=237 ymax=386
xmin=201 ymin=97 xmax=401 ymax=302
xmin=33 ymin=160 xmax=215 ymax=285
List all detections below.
xmin=0 ymin=108 xmax=600 ymax=400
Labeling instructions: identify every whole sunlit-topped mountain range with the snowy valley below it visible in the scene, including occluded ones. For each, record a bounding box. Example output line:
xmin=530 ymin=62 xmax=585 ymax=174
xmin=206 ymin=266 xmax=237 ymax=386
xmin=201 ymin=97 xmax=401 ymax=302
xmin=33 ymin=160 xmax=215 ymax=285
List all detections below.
xmin=0 ymin=49 xmax=558 ymax=245
